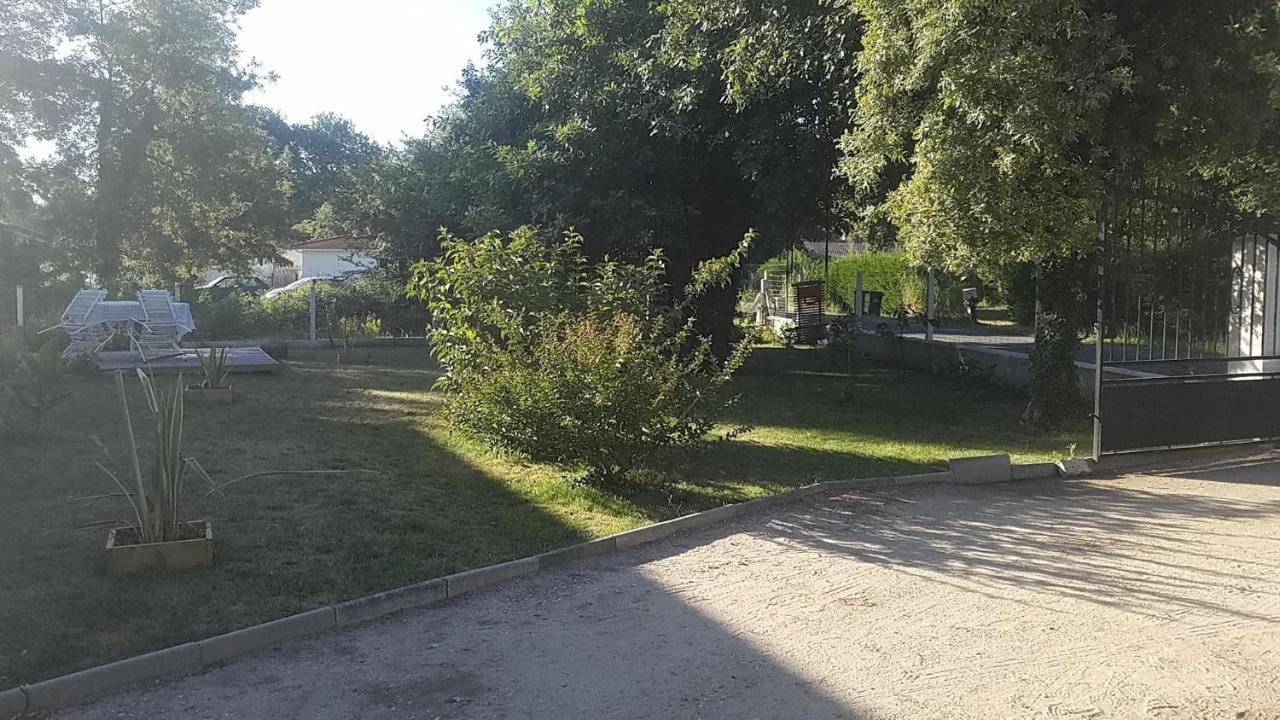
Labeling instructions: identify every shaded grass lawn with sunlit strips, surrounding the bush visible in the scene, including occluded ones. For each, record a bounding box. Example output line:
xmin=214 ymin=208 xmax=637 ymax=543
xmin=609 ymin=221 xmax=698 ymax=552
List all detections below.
xmin=0 ymin=347 xmax=1084 ymax=688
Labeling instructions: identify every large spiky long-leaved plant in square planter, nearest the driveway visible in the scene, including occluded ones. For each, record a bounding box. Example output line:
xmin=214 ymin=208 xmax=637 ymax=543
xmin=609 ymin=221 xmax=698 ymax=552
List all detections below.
xmin=93 ymin=370 xmax=372 ymax=575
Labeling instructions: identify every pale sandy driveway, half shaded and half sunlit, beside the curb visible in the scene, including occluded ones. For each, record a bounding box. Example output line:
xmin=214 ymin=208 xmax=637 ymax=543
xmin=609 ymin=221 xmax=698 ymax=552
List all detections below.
xmin=58 ymin=456 xmax=1280 ymax=720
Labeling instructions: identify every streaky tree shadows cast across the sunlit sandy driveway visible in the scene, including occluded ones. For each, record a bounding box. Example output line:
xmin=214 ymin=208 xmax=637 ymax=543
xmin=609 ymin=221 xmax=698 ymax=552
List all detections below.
xmin=762 ymin=480 xmax=1280 ymax=621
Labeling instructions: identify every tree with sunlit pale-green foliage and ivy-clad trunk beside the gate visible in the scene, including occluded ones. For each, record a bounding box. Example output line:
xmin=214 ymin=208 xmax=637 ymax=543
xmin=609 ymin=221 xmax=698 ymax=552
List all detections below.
xmin=842 ymin=0 xmax=1280 ymax=421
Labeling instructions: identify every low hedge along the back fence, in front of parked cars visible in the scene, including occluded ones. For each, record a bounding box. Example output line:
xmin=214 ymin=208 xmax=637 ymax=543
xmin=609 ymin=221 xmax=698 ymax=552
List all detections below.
xmin=192 ymin=277 xmax=426 ymax=340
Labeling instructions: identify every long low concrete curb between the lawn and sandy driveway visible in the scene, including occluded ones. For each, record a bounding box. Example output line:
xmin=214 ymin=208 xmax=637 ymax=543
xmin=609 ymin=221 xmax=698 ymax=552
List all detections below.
xmin=0 ymin=462 xmax=1059 ymax=717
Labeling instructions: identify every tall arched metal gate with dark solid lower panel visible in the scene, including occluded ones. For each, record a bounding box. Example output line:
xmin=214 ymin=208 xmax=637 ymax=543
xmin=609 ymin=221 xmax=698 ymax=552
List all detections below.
xmin=1094 ymin=188 xmax=1280 ymax=456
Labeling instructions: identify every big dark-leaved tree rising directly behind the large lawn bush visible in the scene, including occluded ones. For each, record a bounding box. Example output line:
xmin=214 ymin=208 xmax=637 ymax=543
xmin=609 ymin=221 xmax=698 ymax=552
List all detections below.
xmin=348 ymin=0 xmax=856 ymax=325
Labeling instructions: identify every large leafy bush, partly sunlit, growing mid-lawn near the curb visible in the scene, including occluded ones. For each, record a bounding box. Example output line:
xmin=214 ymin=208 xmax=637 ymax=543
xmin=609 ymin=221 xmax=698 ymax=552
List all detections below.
xmin=411 ymin=228 xmax=749 ymax=483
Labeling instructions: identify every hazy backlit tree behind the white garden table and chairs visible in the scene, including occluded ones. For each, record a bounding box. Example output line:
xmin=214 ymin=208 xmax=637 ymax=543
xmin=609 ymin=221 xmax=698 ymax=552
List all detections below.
xmin=0 ymin=0 xmax=287 ymax=286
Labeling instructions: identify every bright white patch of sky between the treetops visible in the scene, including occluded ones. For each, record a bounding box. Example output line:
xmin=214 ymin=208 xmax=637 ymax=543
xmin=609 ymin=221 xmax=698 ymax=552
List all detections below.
xmin=239 ymin=0 xmax=497 ymax=142
